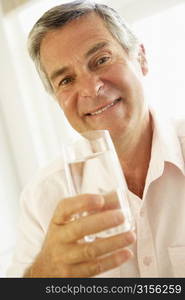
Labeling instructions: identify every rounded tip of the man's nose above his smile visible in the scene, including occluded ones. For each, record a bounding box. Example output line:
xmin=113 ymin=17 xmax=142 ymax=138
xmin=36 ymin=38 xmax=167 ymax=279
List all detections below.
xmin=78 ymin=74 xmax=104 ymax=98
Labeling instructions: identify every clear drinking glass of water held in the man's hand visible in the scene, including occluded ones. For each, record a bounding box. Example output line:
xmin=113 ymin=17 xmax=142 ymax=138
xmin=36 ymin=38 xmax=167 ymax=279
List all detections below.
xmin=64 ymin=130 xmax=133 ymax=242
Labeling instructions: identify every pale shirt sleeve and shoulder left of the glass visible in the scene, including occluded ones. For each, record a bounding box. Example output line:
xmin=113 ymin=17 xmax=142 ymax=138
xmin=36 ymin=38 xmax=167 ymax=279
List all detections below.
xmin=6 ymin=161 xmax=69 ymax=277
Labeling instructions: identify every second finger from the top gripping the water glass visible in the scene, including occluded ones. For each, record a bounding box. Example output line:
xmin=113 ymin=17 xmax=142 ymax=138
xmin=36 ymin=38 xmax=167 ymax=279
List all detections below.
xmin=58 ymin=209 xmax=124 ymax=243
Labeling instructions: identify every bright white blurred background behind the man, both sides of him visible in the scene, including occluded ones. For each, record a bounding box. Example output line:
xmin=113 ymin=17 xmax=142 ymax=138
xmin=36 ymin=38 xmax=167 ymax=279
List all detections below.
xmin=0 ymin=0 xmax=185 ymax=276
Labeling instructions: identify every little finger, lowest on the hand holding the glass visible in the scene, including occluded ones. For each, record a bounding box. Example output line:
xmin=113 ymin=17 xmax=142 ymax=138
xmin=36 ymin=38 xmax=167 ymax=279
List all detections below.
xmin=72 ymin=248 xmax=133 ymax=277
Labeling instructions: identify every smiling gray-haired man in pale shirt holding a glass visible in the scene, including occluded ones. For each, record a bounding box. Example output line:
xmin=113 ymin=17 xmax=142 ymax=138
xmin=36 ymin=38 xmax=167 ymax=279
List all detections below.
xmin=9 ymin=1 xmax=185 ymax=277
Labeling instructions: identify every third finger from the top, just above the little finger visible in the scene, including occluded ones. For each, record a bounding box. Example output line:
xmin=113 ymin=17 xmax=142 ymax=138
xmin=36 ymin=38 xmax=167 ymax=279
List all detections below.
xmin=62 ymin=231 xmax=135 ymax=264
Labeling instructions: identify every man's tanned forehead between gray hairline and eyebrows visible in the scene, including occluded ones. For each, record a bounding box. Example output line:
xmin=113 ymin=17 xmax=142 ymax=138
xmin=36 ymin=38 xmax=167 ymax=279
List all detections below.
xmin=40 ymin=13 xmax=118 ymax=77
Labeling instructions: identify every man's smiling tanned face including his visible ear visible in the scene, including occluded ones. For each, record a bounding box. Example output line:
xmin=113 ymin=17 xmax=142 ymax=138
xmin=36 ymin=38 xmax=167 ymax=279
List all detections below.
xmin=41 ymin=13 xmax=147 ymax=138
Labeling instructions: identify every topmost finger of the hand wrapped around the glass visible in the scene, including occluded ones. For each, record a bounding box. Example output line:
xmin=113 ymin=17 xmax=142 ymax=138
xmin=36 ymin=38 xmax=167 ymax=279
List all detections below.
xmin=52 ymin=194 xmax=104 ymax=225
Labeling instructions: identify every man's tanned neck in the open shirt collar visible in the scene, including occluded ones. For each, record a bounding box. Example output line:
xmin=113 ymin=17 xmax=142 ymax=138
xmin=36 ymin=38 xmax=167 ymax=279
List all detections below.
xmin=112 ymin=114 xmax=153 ymax=198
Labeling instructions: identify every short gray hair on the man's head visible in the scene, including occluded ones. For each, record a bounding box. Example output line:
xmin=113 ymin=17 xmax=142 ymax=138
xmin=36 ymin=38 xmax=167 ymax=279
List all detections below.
xmin=28 ymin=0 xmax=139 ymax=94
